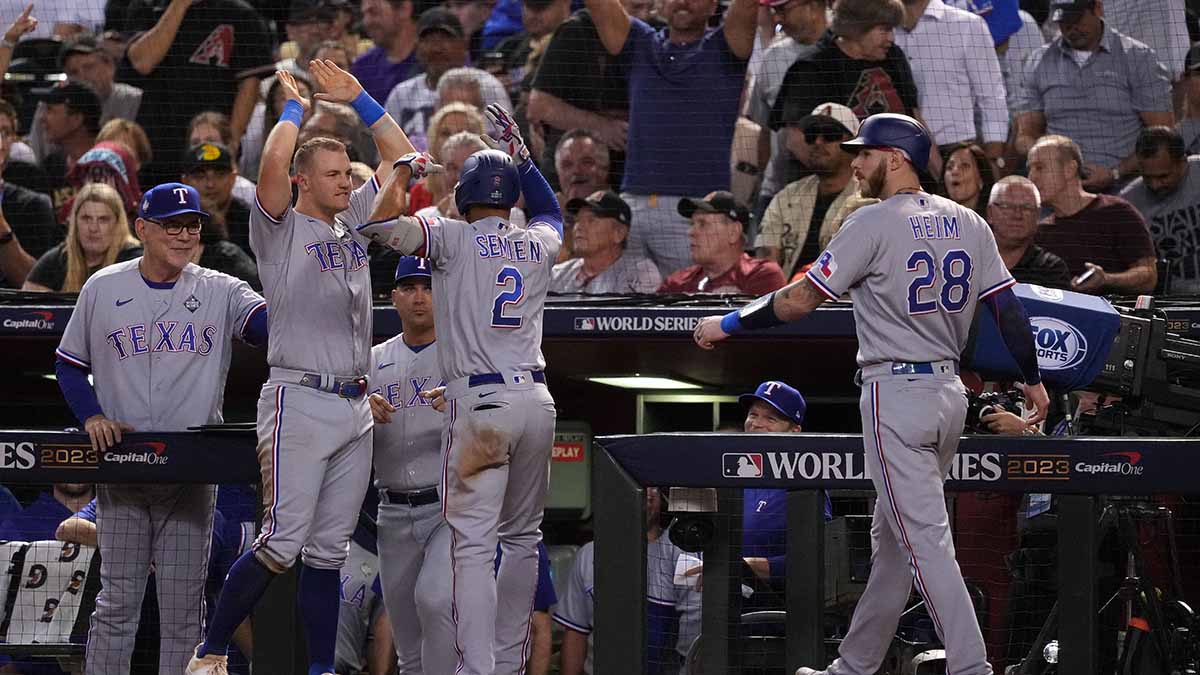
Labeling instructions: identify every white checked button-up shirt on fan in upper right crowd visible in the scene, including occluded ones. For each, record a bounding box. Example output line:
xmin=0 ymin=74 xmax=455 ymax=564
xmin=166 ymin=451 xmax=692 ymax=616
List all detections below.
xmin=895 ymin=0 xmax=1008 ymax=145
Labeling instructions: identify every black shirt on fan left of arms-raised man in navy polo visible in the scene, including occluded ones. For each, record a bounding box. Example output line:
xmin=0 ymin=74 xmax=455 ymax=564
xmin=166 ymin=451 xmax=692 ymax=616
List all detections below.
xmin=529 ymin=10 xmax=629 ymax=177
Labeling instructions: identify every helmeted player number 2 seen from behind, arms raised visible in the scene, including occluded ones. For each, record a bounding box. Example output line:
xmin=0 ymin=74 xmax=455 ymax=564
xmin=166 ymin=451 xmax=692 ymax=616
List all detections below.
xmin=360 ymin=100 xmax=563 ymax=675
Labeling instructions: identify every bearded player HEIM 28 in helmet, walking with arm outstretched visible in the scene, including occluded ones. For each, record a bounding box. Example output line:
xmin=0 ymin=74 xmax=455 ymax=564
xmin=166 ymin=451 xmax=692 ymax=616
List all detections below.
xmin=695 ymin=114 xmax=1049 ymax=675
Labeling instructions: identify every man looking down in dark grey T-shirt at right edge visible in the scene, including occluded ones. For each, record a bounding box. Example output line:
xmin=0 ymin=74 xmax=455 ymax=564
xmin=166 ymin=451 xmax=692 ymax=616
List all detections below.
xmin=1121 ymin=126 xmax=1200 ymax=294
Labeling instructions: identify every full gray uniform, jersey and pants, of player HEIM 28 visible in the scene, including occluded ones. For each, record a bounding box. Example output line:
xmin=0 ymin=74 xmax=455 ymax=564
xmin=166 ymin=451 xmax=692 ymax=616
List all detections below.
xmin=808 ymin=187 xmax=1014 ymax=675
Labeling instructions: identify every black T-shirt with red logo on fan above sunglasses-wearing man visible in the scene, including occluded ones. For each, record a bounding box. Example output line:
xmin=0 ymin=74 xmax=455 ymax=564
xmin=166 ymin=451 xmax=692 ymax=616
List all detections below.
xmin=770 ymin=32 xmax=918 ymax=131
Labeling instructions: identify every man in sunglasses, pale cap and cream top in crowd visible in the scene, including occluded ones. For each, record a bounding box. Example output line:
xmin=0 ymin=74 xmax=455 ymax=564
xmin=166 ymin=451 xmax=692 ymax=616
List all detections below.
xmin=755 ymin=102 xmax=877 ymax=279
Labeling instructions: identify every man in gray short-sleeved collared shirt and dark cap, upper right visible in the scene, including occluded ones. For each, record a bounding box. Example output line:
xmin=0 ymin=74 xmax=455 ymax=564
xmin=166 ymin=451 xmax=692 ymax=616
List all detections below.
xmin=1013 ymin=0 xmax=1175 ymax=192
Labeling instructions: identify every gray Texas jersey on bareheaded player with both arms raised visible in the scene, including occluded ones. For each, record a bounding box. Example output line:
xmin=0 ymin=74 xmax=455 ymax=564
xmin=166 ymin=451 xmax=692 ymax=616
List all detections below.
xmin=250 ymin=177 xmax=379 ymax=377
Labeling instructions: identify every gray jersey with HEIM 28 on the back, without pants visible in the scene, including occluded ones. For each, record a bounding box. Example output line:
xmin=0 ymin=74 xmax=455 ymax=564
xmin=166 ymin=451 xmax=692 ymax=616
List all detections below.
xmin=808 ymin=192 xmax=1015 ymax=366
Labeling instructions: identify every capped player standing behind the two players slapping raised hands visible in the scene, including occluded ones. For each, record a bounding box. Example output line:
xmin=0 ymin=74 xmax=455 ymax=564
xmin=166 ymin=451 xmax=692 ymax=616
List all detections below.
xmin=370 ymin=256 xmax=458 ymax=675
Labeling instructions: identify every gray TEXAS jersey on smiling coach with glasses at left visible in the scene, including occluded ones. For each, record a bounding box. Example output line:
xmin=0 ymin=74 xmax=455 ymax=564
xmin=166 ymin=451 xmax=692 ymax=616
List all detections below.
xmin=56 ymin=258 xmax=270 ymax=431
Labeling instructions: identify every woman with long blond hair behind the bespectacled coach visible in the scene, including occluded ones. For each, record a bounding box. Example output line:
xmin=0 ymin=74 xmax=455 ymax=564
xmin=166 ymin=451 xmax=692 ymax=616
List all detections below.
xmin=22 ymin=183 xmax=142 ymax=293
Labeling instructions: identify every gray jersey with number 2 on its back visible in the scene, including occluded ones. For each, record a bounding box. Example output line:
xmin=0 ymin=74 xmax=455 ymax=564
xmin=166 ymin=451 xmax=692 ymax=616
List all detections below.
xmin=418 ymin=216 xmax=562 ymax=381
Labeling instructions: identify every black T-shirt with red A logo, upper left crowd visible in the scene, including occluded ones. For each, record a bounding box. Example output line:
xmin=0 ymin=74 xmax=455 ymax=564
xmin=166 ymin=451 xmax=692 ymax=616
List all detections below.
xmin=119 ymin=0 xmax=275 ymax=185
